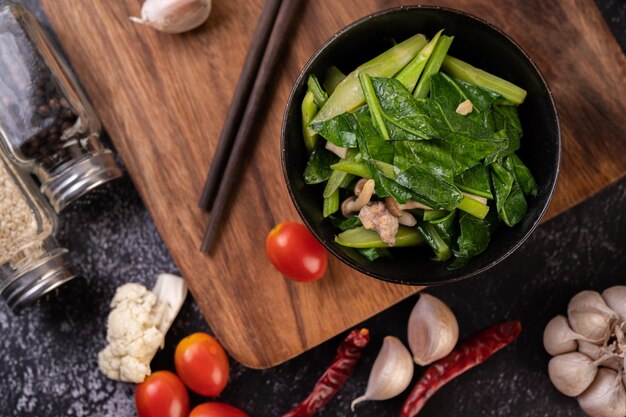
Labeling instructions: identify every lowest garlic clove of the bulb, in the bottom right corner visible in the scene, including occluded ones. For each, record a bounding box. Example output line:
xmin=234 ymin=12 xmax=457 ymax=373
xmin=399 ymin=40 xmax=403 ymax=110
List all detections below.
xmin=578 ymin=368 xmax=626 ymax=417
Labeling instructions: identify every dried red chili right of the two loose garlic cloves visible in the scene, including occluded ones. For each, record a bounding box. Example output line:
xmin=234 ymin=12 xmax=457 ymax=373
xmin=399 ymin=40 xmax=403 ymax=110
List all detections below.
xmin=400 ymin=321 xmax=522 ymax=417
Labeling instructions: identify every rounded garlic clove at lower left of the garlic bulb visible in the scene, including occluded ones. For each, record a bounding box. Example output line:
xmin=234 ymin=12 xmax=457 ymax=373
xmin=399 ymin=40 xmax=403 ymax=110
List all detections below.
xmin=548 ymin=352 xmax=596 ymax=396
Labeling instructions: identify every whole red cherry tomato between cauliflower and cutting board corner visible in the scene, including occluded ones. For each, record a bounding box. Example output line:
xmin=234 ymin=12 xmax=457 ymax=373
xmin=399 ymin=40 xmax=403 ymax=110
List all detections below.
xmin=174 ymin=333 xmax=230 ymax=397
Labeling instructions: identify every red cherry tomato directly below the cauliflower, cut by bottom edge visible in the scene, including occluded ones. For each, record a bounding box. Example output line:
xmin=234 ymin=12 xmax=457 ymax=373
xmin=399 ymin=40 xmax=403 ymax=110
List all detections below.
xmin=135 ymin=371 xmax=189 ymax=417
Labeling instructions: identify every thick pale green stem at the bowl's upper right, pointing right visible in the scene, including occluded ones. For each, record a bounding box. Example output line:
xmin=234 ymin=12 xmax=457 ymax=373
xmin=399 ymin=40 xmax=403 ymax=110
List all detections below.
xmin=442 ymin=56 xmax=526 ymax=105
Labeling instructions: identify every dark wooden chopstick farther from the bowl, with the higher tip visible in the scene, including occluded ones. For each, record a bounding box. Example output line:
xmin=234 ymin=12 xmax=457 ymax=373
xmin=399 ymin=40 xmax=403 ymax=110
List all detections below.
xmin=199 ymin=0 xmax=281 ymax=210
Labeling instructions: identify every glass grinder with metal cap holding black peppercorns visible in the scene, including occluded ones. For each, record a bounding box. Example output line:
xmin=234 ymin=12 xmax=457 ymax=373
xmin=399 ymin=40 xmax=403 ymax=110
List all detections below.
xmin=0 ymin=2 xmax=122 ymax=212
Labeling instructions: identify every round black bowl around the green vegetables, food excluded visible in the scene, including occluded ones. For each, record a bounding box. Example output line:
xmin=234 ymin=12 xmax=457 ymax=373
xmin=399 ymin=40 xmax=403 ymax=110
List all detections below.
xmin=281 ymin=6 xmax=561 ymax=285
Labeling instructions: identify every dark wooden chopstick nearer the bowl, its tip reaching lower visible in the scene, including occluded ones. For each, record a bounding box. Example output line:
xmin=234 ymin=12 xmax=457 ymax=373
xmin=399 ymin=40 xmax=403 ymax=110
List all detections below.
xmin=200 ymin=0 xmax=303 ymax=253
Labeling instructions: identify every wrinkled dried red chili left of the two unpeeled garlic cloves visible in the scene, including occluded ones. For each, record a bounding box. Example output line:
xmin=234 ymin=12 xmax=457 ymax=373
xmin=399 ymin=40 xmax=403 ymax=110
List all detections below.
xmin=283 ymin=329 xmax=370 ymax=417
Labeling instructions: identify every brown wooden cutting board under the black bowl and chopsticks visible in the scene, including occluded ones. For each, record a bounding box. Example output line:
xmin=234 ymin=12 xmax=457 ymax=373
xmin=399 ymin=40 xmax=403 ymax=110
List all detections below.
xmin=42 ymin=0 xmax=626 ymax=368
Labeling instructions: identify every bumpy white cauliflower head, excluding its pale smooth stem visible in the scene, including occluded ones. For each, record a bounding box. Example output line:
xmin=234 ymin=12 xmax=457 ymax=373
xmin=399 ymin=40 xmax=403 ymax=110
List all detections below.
xmin=98 ymin=283 xmax=165 ymax=383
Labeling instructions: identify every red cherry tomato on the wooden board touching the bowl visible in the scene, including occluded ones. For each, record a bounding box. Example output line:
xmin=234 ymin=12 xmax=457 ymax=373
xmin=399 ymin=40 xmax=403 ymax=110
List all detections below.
xmin=265 ymin=222 xmax=328 ymax=282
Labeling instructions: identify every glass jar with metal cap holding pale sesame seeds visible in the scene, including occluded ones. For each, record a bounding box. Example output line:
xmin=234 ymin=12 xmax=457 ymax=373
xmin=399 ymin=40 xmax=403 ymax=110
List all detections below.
xmin=0 ymin=154 xmax=75 ymax=308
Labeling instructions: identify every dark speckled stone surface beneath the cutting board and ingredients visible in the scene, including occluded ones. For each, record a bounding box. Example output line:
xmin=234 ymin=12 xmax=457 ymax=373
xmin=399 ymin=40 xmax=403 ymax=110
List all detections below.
xmin=0 ymin=0 xmax=626 ymax=417
